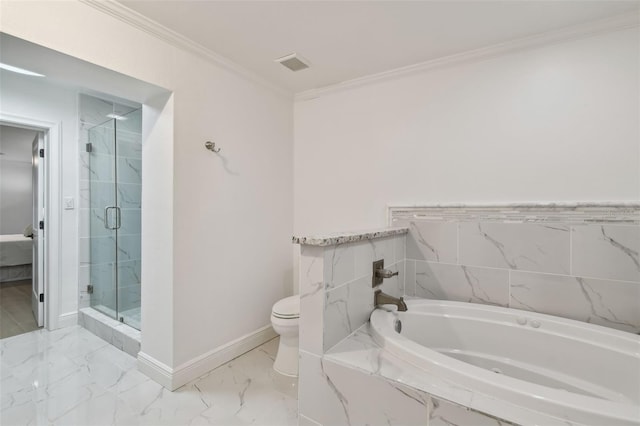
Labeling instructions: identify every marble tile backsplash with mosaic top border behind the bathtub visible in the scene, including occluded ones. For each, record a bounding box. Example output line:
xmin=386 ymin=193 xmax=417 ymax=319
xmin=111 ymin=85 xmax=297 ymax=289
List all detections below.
xmin=389 ymin=204 xmax=640 ymax=333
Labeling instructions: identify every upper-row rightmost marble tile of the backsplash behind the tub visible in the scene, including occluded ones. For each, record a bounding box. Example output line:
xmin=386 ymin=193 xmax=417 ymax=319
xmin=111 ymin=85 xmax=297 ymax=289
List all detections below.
xmin=571 ymin=224 xmax=640 ymax=282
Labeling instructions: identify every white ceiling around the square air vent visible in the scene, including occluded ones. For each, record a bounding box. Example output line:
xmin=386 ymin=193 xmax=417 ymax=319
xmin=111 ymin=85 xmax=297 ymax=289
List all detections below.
xmin=120 ymin=0 xmax=640 ymax=93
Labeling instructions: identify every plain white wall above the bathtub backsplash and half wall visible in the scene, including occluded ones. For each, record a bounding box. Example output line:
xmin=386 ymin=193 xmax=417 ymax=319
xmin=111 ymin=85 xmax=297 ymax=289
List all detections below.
xmin=294 ymin=29 xmax=640 ymax=234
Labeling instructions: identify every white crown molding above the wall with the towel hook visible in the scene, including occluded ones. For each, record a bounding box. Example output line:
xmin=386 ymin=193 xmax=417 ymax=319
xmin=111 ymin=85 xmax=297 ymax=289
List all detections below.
xmin=79 ymin=0 xmax=293 ymax=99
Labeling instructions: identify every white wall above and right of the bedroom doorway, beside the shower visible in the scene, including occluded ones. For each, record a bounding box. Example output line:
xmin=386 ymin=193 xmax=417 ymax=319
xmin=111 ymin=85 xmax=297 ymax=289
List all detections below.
xmin=0 ymin=72 xmax=78 ymax=317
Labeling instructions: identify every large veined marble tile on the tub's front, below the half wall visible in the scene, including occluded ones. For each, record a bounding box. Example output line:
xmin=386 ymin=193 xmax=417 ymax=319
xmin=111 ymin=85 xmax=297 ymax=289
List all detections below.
xmin=299 ymin=353 xmax=429 ymax=426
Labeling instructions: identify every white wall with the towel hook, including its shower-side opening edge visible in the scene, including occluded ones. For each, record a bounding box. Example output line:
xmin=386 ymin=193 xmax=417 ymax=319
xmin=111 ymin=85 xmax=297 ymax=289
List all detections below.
xmin=1 ymin=1 xmax=293 ymax=367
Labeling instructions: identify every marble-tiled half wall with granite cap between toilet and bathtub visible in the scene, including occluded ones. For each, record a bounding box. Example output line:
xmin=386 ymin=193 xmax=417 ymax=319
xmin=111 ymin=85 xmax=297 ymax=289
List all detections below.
xmin=300 ymin=228 xmax=407 ymax=355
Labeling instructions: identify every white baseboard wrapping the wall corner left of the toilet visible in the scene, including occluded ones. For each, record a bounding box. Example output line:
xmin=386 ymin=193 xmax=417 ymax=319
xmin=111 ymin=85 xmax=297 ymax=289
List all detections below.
xmin=138 ymin=325 xmax=278 ymax=390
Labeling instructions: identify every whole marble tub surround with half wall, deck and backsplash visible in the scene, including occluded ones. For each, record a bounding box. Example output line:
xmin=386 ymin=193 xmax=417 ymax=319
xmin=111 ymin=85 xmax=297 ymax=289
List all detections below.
xmin=294 ymin=203 xmax=640 ymax=426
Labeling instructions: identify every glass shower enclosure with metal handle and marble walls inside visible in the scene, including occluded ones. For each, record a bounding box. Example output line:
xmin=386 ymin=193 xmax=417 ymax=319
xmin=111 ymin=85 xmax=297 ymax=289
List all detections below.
xmin=84 ymin=105 xmax=142 ymax=330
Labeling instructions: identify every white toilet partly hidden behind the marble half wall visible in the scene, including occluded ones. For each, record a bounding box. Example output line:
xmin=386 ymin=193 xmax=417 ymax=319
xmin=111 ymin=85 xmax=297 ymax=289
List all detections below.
xmin=271 ymin=295 xmax=300 ymax=377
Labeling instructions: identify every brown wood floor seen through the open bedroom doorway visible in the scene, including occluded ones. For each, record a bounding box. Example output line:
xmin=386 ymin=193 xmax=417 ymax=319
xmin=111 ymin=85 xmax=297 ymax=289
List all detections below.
xmin=0 ymin=280 xmax=38 ymax=339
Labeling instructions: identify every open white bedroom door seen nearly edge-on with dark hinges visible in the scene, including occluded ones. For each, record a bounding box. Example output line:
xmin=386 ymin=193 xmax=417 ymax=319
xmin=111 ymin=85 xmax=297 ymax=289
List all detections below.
xmin=31 ymin=132 xmax=45 ymax=327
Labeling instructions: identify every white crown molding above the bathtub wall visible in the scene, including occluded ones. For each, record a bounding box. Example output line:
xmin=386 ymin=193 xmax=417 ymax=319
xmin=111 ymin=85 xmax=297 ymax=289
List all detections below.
xmin=295 ymin=12 xmax=640 ymax=101
